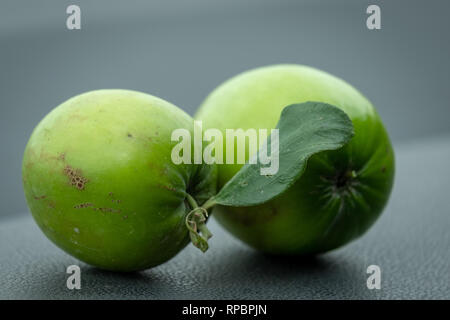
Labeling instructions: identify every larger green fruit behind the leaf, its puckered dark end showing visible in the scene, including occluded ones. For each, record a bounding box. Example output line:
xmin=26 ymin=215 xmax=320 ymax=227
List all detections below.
xmin=196 ymin=65 xmax=394 ymax=255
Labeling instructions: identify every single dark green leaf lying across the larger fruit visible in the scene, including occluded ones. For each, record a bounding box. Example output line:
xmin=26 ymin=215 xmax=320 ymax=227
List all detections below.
xmin=213 ymin=102 xmax=354 ymax=207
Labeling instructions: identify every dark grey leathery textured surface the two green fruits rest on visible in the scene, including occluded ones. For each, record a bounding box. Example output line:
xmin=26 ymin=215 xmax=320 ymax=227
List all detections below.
xmin=0 ymin=136 xmax=450 ymax=299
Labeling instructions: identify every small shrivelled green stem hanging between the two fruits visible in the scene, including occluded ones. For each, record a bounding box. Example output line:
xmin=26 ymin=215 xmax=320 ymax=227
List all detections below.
xmin=185 ymin=194 xmax=212 ymax=252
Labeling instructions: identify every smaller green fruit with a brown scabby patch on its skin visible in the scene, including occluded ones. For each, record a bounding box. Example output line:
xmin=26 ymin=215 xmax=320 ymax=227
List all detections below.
xmin=22 ymin=90 xmax=216 ymax=271
